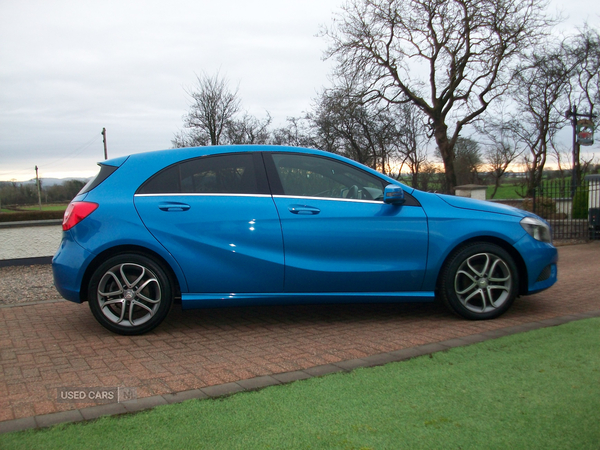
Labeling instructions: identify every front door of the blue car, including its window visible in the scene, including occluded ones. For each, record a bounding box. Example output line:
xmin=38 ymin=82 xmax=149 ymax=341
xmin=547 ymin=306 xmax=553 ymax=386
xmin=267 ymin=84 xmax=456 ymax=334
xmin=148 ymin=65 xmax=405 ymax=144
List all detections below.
xmin=264 ymin=153 xmax=428 ymax=293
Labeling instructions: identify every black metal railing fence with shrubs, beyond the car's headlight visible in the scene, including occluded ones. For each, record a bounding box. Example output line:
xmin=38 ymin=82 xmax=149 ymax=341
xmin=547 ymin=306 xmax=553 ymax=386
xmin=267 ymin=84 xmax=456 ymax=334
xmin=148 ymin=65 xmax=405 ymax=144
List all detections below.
xmin=523 ymin=175 xmax=600 ymax=241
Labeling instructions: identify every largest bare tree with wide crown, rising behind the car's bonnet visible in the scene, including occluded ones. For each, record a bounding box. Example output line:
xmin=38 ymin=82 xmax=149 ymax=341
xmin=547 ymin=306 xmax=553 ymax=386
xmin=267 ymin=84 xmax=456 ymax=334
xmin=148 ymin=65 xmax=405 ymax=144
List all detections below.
xmin=325 ymin=0 xmax=550 ymax=190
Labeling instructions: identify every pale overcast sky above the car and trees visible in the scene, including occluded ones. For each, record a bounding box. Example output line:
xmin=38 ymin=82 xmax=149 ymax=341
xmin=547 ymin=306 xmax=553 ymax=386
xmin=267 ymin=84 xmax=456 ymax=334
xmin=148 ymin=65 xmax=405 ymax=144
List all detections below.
xmin=0 ymin=0 xmax=600 ymax=180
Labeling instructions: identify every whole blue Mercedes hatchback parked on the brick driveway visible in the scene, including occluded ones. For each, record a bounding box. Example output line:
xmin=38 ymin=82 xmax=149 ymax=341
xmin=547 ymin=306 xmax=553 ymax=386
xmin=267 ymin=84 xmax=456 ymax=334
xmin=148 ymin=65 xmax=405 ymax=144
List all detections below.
xmin=52 ymin=146 xmax=558 ymax=335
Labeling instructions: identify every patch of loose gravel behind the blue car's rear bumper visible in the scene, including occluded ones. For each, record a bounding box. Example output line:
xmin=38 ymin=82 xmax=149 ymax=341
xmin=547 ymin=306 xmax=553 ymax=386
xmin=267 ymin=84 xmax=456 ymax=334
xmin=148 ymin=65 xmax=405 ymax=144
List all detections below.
xmin=0 ymin=264 xmax=61 ymax=305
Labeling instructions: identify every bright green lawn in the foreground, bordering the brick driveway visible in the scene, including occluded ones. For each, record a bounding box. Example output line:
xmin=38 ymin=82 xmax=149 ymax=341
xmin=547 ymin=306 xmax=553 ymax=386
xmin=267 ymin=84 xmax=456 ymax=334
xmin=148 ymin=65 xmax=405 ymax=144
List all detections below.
xmin=0 ymin=319 xmax=600 ymax=450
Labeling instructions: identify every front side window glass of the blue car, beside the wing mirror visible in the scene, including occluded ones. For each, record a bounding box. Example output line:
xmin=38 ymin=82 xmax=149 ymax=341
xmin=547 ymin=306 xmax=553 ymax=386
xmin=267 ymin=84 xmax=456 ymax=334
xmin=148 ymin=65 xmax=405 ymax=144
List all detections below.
xmin=273 ymin=154 xmax=384 ymax=200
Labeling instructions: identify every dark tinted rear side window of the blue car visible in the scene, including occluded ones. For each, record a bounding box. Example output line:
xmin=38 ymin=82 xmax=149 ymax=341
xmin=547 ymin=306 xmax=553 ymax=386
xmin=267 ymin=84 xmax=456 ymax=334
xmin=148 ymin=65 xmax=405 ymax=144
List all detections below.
xmin=139 ymin=153 xmax=265 ymax=194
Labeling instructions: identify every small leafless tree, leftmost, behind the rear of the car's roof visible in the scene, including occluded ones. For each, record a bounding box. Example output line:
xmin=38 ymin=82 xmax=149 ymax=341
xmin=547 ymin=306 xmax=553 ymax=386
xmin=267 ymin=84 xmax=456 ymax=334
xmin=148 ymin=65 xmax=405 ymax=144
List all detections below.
xmin=171 ymin=74 xmax=240 ymax=147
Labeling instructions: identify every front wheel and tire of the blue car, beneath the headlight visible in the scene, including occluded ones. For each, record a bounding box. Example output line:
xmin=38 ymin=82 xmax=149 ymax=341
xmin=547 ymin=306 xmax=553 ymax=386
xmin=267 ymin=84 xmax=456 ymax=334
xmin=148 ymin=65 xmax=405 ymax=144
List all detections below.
xmin=438 ymin=242 xmax=519 ymax=320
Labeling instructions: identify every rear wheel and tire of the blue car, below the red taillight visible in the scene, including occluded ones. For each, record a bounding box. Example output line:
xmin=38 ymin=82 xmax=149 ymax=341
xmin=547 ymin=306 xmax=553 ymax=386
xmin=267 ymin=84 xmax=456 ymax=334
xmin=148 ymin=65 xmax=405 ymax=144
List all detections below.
xmin=88 ymin=253 xmax=173 ymax=335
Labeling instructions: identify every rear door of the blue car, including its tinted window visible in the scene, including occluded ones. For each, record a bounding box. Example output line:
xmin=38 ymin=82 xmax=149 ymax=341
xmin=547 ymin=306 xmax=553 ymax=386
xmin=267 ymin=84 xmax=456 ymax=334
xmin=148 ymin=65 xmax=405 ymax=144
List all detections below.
xmin=135 ymin=152 xmax=284 ymax=293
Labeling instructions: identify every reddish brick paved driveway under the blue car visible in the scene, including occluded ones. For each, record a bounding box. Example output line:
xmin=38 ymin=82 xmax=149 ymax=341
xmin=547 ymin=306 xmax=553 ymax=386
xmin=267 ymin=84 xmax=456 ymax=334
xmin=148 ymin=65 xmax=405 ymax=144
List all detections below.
xmin=0 ymin=242 xmax=600 ymax=422
